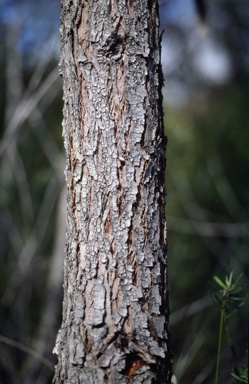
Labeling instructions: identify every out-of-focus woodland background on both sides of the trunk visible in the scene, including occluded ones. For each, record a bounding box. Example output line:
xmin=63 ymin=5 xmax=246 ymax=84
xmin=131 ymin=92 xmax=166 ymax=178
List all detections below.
xmin=0 ymin=0 xmax=249 ymax=384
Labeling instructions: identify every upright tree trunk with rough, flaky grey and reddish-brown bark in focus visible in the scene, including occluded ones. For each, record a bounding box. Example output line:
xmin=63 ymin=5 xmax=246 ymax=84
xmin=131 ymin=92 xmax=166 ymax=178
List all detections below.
xmin=54 ymin=0 xmax=171 ymax=384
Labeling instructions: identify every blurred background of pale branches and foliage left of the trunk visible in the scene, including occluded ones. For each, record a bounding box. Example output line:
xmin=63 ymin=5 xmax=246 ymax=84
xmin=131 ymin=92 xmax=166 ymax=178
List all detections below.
xmin=0 ymin=0 xmax=65 ymax=384
